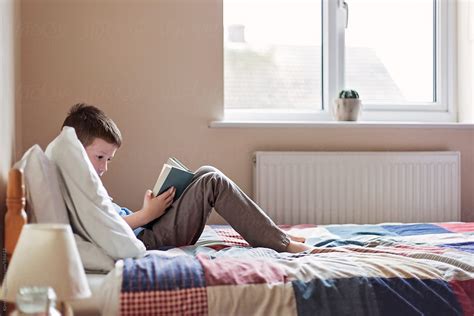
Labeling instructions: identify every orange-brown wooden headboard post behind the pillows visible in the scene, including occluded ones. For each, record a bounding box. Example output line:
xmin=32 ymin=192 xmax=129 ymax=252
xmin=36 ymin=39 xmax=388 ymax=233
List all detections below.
xmin=4 ymin=169 xmax=27 ymax=261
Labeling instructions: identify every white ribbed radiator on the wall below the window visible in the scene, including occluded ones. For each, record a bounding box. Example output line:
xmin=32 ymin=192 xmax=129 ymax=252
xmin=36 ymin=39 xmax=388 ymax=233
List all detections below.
xmin=253 ymin=152 xmax=461 ymax=224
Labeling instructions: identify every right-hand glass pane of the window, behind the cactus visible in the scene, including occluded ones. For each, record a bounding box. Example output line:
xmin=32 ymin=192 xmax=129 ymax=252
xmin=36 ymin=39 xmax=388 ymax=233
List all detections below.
xmin=345 ymin=0 xmax=435 ymax=103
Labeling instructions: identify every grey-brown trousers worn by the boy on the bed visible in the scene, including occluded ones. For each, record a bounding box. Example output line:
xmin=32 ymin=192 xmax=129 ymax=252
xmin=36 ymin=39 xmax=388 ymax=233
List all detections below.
xmin=138 ymin=166 xmax=290 ymax=252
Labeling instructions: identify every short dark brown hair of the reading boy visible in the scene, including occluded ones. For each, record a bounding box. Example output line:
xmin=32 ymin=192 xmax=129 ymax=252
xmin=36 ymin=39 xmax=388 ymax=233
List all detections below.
xmin=62 ymin=103 xmax=122 ymax=147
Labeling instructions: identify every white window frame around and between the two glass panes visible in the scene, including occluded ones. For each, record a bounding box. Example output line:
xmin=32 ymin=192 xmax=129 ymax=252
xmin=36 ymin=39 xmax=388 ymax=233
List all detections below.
xmin=223 ymin=0 xmax=458 ymax=123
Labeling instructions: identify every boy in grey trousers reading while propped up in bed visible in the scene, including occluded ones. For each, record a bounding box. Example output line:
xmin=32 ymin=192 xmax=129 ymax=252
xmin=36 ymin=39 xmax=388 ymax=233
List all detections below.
xmin=63 ymin=103 xmax=311 ymax=252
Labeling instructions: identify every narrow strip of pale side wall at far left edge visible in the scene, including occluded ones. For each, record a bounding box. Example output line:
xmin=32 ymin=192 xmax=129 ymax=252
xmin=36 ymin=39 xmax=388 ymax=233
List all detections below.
xmin=0 ymin=0 xmax=20 ymax=280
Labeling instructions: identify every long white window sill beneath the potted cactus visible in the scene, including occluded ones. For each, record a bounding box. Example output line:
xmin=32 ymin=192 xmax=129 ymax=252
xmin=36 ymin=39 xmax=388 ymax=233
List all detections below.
xmin=209 ymin=121 xmax=474 ymax=129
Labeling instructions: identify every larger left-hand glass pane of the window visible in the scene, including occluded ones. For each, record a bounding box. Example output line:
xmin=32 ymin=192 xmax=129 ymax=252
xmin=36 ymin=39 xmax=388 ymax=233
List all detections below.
xmin=224 ymin=0 xmax=322 ymax=110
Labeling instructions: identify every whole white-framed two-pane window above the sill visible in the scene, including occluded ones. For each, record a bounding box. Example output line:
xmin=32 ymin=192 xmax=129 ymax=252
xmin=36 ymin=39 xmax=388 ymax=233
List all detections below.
xmin=224 ymin=0 xmax=456 ymax=121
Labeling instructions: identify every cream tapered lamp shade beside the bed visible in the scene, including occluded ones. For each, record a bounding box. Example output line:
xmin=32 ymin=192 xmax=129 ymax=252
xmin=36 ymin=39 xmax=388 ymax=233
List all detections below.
xmin=0 ymin=224 xmax=91 ymax=302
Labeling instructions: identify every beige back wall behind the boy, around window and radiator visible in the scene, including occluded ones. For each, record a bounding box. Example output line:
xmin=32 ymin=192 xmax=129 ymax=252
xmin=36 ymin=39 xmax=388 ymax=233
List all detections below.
xmin=21 ymin=0 xmax=474 ymax=220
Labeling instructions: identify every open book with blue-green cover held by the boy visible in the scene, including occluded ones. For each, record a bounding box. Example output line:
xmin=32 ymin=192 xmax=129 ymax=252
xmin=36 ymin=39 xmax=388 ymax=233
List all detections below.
xmin=153 ymin=157 xmax=194 ymax=200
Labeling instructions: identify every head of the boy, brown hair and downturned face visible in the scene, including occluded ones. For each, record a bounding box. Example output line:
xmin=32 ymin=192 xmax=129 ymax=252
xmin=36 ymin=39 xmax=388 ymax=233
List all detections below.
xmin=63 ymin=103 xmax=122 ymax=176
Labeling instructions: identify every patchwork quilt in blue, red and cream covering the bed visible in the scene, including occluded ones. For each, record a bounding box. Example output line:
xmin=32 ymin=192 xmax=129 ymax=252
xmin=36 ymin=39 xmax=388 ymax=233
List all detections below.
xmin=120 ymin=222 xmax=474 ymax=315
